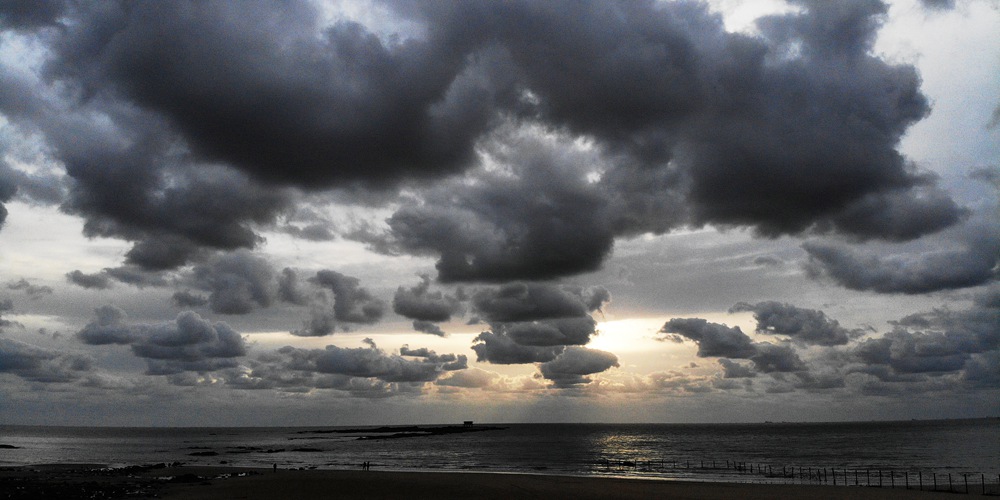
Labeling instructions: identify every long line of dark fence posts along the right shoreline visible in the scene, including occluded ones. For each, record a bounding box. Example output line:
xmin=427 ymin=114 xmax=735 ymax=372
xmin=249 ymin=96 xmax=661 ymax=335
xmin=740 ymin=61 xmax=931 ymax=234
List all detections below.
xmin=593 ymin=459 xmax=1000 ymax=496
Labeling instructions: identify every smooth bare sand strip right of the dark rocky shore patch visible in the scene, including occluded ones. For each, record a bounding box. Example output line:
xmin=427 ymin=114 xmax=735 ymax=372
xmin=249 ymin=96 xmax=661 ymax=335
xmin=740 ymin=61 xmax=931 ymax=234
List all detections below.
xmin=160 ymin=470 xmax=968 ymax=500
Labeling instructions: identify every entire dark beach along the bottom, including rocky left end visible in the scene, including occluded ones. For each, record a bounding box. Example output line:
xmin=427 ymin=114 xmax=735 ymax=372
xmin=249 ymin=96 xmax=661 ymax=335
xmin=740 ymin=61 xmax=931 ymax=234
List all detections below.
xmin=0 ymin=464 xmax=978 ymax=500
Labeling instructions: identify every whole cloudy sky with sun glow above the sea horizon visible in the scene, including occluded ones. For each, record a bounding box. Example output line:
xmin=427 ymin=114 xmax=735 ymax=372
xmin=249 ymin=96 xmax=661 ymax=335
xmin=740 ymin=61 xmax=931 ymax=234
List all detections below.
xmin=0 ymin=0 xmax=1000 ymax=426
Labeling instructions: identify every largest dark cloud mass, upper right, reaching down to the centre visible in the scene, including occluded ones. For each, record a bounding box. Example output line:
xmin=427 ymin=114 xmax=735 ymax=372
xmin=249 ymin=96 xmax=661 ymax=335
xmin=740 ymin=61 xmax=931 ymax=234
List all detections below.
xmin=372 ymin=1 xmax=965 ymax=281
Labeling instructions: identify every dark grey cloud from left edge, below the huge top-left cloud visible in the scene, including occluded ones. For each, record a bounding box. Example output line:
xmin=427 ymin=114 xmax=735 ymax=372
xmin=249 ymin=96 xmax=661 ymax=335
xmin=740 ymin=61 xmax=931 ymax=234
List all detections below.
xmin=0 ymin=39 xmax=290 ymax=270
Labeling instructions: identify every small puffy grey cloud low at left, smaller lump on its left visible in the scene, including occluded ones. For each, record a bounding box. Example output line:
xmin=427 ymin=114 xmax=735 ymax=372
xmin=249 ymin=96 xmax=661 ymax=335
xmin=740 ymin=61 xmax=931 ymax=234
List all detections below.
xmin=76 ymin=306 xmax=247 ymax=375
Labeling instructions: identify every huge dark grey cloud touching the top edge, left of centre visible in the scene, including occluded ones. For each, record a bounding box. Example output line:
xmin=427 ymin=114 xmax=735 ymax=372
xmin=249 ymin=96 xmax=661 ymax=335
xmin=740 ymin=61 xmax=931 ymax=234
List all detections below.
xmin=52 ymin=1 xmax=490 ymax=187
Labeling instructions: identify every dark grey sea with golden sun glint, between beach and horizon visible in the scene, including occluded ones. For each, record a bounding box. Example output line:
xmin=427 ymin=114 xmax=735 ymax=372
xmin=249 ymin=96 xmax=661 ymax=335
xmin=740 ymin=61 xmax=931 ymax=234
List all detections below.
xmin=0 ymin=418 xmax=1000 ymax=485
